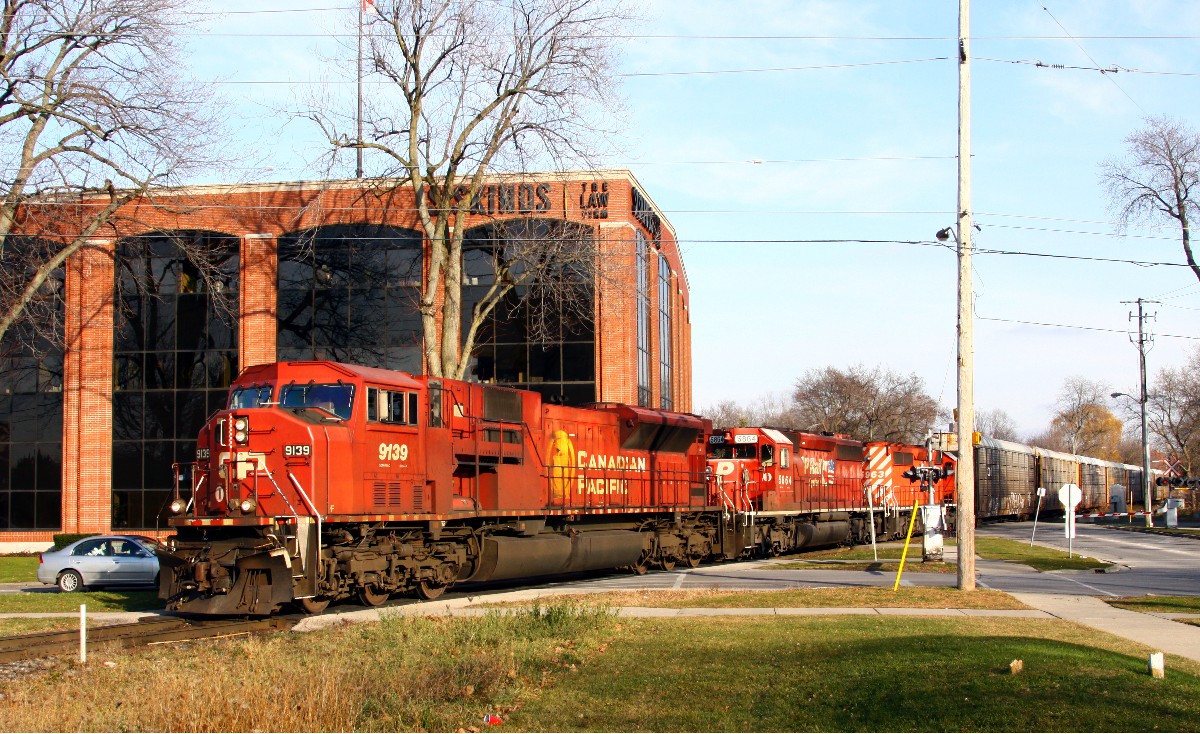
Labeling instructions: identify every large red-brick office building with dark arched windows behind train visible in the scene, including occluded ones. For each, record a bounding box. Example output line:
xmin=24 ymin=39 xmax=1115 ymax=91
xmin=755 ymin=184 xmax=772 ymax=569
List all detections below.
xmin=0 ymin=170 xmax=691 ymax=549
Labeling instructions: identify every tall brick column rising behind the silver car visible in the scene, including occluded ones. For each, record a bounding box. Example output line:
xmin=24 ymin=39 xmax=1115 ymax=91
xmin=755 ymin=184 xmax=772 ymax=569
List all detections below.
xmin=62 ymin=240 xmax=114 ymax=533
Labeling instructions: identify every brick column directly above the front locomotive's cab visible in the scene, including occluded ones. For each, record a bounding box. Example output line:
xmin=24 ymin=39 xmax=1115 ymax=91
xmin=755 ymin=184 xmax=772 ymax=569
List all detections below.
xmin=238 ymin=234 xmax=280 ymax=372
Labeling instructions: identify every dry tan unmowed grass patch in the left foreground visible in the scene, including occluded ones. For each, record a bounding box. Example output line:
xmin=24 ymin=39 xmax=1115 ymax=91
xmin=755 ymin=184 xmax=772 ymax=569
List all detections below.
xmin=0 ymin=606 xmax=614 ymax=732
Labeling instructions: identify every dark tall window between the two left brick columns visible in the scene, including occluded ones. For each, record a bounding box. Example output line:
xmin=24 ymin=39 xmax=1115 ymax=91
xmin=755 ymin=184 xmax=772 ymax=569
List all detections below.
xmin=113 ymin=231 xmax=238 ymax=529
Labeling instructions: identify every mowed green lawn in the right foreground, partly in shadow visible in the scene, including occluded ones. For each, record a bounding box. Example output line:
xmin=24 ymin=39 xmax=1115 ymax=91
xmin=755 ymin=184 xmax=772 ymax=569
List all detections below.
xmin=511 ymin=618 xmax=1200 ymax=732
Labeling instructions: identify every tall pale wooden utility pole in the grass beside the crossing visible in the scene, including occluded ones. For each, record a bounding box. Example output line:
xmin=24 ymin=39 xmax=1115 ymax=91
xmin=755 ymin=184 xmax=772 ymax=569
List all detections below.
xmin=954 ymin=0 xmax=976 ymax=591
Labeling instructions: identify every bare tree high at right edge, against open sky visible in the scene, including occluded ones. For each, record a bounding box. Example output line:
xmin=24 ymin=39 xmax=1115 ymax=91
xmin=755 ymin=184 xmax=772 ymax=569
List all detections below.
xmin=1100 ymin=116 xmax=1200 ymax=279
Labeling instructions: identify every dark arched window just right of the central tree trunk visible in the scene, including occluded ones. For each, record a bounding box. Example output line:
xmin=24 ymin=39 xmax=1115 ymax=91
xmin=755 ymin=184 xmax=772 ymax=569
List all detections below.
xmin=462 ymin=219 xmax=596 ymax=405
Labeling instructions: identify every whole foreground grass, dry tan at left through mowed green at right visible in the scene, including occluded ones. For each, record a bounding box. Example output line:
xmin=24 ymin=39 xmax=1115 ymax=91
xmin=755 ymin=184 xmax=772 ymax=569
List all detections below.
xmin=0 ymin=607 xmax=1200 ymax=734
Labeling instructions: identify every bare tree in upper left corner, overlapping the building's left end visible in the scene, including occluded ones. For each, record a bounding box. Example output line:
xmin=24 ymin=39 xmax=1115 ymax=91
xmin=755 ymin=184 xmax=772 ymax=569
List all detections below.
xmin=0 ymin=0 xmax=223 ymax=350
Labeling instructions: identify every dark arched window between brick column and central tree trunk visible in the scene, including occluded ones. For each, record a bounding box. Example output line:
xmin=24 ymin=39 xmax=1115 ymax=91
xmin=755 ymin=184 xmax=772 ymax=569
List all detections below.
xmin=276 ymin=224 xmax=421 ymax=373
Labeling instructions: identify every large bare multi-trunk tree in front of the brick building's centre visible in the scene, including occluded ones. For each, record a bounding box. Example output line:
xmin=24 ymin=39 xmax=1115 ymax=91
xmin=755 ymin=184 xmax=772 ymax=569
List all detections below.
xmin=308 ymin=0 xmax=623 ymax=378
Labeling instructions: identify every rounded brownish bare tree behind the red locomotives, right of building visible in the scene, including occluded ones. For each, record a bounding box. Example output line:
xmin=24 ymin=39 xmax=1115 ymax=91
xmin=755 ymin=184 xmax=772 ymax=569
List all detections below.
xmin=791 ymin=365 xmax=938 ymax=443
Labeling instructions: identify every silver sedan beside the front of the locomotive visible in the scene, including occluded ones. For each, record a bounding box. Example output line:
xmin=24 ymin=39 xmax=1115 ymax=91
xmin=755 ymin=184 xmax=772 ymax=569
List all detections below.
xmin=37 ymin=535 xmax=162 ymax=591
